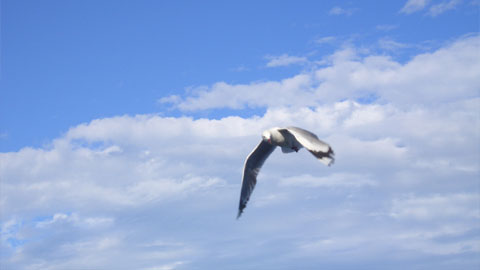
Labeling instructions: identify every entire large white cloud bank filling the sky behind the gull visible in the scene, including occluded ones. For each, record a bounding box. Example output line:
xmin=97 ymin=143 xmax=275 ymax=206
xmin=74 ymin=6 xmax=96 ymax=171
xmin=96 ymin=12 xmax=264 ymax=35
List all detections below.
xmin=0 ymin=36 xmax=480 ymax=269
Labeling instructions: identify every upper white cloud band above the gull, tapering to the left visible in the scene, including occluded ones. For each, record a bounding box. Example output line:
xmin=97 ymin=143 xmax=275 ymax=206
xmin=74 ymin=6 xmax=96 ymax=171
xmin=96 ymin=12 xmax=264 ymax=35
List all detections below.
xmin=160 ymin=36 xmax=480 ymax=111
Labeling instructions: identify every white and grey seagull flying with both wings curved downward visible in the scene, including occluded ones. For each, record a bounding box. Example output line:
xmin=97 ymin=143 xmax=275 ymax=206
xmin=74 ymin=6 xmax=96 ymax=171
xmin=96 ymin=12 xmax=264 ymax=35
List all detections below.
xmin=237 ymin=127 xmax=335 ymax=219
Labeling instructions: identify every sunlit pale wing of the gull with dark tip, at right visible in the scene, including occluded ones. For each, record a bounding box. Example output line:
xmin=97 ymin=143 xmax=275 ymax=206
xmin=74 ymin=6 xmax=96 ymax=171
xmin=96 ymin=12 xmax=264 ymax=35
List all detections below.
xmin=286 ymin=127 xmax=335 ymax=166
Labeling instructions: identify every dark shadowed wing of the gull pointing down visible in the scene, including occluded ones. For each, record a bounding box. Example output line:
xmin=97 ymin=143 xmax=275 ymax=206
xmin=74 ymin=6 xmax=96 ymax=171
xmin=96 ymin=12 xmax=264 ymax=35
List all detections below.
xmin=237 ymin=140 xmax=276 ymax=218
